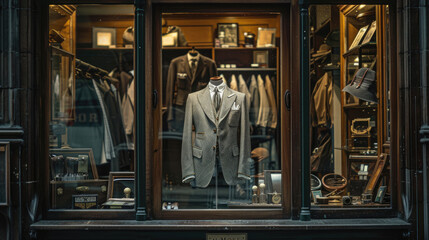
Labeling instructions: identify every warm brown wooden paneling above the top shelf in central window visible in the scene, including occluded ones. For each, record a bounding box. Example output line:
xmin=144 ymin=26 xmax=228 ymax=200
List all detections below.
xmin=162 ymin=13 xmax=280 ymax=47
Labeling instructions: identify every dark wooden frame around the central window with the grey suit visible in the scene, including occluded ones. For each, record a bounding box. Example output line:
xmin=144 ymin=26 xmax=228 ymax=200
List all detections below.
xmin=146 ymin=3 xmax=291 ymax=219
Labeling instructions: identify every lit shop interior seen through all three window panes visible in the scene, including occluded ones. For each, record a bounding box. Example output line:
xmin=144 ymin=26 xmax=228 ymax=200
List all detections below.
xmin=49 ymin=5 xmax=392 ymax=211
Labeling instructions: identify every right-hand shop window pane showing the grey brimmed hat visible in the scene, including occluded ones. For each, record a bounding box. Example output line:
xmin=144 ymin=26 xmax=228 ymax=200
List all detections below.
xmin=309 ymin=5 xmax=392 ymax=209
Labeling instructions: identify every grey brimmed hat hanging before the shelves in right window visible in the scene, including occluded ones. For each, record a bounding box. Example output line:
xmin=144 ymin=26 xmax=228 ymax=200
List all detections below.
xmin=343 ymin=68 xmax=378 ymax=103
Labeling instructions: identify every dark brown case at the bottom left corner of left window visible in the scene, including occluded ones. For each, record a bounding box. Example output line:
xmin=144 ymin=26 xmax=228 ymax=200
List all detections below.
xmin=50 ymin=179 xmax=108 ymax=209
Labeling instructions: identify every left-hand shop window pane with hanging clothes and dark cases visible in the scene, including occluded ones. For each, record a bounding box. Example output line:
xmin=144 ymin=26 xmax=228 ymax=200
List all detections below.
xmin=46 ymin=5 xmax=135 ymax=209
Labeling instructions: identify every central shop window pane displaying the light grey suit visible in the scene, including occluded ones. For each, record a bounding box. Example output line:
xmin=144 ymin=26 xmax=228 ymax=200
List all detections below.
xmin=154 ymin=12 xmax=286 ymax=211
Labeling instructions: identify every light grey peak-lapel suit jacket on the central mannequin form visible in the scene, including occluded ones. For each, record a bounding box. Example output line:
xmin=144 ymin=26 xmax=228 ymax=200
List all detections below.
xmin=182 ymin=84 xmax=252 ymax=187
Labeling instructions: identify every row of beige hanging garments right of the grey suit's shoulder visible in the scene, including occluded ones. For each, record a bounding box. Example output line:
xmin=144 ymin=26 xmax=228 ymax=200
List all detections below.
xmin=221 ymin=74 xmax=278 ymax=128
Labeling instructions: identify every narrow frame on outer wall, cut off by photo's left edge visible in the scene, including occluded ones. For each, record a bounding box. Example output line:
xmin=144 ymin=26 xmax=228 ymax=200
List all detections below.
xmin=0 ymin=142 xmax=10 ymax=206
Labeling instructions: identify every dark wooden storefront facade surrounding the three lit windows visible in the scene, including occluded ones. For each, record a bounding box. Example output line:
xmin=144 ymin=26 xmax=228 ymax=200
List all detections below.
xmin=0 ymin=0 xmax=429 ymax=239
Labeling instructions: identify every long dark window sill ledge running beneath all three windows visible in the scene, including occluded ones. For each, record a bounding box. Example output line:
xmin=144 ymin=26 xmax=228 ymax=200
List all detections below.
xmin=31 ymin=218 xmax=410 ymax=231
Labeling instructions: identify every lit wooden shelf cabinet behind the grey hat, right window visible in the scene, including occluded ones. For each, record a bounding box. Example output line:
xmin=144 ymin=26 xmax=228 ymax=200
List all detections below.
xmin=339 ymin=5 xmax=390 ymax=201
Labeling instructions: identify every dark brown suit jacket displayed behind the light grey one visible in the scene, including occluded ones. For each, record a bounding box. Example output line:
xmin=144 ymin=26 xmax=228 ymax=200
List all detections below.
xmin=165 ymin=54 xmax=217 ymax=131
